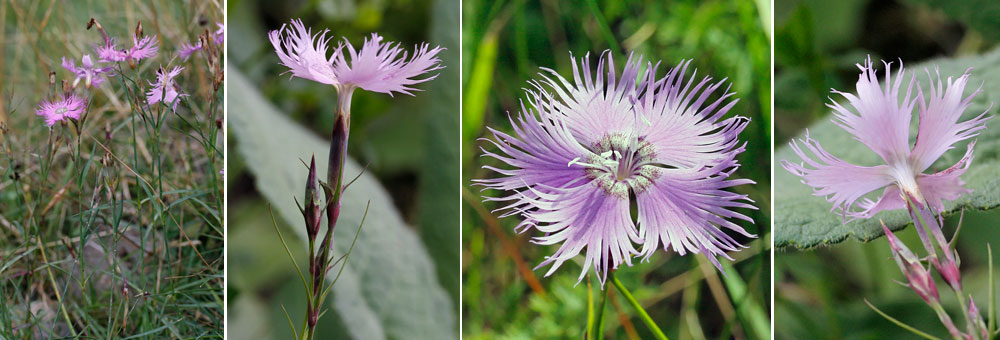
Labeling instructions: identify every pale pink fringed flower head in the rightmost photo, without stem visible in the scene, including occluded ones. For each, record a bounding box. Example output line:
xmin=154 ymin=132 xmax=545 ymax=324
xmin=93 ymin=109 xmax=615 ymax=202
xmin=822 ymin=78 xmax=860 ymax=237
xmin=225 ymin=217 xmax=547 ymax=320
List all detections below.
xmin=781 ymin=58 xmax=989 ymax=223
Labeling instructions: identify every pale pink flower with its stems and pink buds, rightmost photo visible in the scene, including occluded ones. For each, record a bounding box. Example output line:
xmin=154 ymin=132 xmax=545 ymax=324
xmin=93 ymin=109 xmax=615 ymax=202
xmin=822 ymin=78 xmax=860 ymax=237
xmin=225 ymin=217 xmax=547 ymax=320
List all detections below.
xmin=782 ymin=58 xmax=989 ymax=339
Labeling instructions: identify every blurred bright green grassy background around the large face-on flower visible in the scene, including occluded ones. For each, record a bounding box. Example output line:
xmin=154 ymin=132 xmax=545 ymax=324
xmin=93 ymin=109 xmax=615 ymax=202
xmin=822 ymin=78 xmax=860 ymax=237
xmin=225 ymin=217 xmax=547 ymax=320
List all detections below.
xmin=462 ymin=0 xmax=771 ymax=339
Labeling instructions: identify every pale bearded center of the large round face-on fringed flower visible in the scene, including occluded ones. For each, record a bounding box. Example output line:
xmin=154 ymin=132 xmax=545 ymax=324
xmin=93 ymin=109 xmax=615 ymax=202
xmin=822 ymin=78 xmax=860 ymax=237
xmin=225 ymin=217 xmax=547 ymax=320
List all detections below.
xmin=569 ymin=133 xmax=660 ymax=198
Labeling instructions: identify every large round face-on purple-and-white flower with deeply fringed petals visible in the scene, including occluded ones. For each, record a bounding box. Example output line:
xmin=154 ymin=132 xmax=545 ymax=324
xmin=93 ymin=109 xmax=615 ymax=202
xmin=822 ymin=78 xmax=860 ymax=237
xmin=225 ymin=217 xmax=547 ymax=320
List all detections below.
xmin=476 ymin=52 xmax=756 ymax=284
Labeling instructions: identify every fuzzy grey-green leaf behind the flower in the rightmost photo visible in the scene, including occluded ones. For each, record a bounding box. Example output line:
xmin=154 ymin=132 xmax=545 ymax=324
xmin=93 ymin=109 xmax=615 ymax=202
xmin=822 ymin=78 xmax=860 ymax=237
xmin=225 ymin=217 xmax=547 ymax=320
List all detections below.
xmin=774 ymin=49 xmax=1000 ymax=249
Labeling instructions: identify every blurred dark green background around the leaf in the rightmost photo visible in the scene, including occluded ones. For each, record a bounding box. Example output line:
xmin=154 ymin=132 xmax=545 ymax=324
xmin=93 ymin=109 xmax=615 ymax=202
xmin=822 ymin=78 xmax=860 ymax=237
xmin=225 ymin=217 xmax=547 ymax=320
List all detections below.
xmin=774 ymin=0 xmax=1000 ymax=339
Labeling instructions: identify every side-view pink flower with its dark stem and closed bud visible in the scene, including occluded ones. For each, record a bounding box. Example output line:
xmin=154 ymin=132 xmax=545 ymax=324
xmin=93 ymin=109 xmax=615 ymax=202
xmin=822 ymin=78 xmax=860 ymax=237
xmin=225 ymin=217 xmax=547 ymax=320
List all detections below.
xmin=268 ymin=20 xmax=443 ymax=339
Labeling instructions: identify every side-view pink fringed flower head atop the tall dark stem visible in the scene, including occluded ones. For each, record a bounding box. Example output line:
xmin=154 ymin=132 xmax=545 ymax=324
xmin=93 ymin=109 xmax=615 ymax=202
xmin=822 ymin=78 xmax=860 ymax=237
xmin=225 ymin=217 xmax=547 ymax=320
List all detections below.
xmin=268 ymin=20 xmax=442 ymax=95
